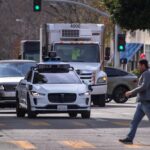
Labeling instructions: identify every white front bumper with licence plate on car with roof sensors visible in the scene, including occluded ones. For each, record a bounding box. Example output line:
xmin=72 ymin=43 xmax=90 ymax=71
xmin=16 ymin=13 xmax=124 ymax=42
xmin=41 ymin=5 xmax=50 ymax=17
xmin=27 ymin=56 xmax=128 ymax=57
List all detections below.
xmin=30 ymin=95 xmax=91 ymax=113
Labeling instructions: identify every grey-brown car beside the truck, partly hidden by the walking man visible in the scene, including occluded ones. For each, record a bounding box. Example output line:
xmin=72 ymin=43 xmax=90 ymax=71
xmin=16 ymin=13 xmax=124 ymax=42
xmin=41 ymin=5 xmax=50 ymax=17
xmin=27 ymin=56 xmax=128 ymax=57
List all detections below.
xmin=105 ymin=67 xmax=138 ymax=103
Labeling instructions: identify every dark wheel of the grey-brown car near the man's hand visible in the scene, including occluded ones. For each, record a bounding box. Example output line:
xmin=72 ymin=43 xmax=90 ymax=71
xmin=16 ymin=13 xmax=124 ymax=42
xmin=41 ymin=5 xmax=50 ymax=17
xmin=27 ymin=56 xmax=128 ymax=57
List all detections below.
xmin=113 ymin=86 xmax=129 ymax=103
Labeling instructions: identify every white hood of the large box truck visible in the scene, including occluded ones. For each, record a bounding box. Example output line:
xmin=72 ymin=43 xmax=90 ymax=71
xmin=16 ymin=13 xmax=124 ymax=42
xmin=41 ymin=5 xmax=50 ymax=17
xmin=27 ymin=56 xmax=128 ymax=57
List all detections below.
xmin=69 ymin=62 xmax=100 ymax=71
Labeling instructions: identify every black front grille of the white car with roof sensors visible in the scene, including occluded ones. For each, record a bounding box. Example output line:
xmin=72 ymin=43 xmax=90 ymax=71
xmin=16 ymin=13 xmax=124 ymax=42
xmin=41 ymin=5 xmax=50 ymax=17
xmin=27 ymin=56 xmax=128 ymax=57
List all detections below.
xmin=48 ymin=93 xmax=76 ymax=103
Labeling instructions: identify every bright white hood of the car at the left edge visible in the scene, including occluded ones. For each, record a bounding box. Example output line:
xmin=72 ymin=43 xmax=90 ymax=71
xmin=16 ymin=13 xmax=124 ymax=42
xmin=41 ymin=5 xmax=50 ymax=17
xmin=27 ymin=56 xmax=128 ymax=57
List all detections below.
xmin=0 ymin=77 xmax=24 ymax=83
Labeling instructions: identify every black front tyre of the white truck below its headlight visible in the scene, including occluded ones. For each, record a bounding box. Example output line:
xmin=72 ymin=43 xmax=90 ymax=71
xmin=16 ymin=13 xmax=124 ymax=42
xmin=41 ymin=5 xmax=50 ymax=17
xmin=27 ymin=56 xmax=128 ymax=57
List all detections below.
xmin=92 ymin=95 xmax=106 ymax=107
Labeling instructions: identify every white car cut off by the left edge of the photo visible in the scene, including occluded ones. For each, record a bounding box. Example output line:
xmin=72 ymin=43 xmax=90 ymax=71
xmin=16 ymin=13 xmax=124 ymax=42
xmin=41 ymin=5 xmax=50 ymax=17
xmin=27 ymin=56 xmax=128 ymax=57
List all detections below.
xmin=0 ymin=60 xmax=36 ymax=106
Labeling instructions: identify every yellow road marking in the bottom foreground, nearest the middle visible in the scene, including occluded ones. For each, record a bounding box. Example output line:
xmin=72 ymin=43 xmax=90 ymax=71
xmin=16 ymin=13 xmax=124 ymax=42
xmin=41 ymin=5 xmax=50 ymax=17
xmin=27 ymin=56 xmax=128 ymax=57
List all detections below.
xmin=60 ymin=140 xmax=96 ymax=149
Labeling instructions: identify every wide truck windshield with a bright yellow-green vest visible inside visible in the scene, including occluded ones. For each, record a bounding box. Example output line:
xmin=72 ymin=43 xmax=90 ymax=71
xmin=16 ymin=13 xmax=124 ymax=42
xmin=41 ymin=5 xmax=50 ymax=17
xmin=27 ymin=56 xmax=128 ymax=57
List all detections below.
xmin=54 ymin=43 xmax=100 ymax=63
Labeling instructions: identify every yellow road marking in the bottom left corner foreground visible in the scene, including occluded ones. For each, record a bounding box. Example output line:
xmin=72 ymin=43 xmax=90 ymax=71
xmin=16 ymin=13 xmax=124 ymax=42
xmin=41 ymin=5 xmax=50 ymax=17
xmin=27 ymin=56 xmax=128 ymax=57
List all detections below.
xmin=9 ymin=141 xmax=37 ymax=150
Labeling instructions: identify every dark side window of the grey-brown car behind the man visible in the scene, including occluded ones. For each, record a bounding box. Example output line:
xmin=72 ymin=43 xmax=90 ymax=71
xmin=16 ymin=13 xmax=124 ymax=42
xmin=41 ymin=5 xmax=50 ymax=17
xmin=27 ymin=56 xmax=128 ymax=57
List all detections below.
xmin=105 ymin=67 xmax=128 ymax=77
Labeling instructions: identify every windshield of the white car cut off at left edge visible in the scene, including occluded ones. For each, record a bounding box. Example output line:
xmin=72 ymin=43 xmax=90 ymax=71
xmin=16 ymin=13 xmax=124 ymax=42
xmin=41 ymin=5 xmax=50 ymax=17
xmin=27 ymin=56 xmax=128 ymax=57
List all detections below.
xmin=0 ymin=62 xmax=36 ymax=77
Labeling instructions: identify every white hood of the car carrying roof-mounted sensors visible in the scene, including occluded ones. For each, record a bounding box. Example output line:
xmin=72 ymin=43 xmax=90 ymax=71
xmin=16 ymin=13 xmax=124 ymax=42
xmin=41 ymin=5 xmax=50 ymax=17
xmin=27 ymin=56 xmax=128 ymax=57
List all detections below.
xmin=34 ymin=84 xmax=87 ymax=93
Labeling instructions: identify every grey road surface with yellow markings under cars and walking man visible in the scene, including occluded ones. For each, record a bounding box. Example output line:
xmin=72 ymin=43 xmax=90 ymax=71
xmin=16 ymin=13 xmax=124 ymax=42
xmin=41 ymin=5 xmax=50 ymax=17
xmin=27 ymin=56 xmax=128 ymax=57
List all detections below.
xmin=0 ymin=100 xmax=150 ymax=150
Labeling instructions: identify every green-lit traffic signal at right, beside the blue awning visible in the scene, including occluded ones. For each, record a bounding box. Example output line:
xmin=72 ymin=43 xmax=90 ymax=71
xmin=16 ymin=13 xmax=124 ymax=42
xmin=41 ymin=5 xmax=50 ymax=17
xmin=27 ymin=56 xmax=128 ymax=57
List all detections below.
xmin=117 ymin=34 xmax=126 ymax=52
